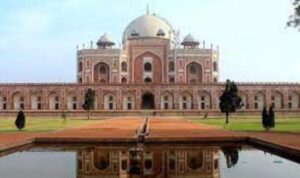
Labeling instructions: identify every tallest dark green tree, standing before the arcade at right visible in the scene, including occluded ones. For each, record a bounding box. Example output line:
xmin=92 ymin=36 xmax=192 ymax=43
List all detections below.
xmin=219 ymin=80 xmax=243 ymax=124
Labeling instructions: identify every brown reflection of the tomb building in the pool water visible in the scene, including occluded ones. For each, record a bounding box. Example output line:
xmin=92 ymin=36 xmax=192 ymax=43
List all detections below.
xmin=77 ymin=145 xmax=224 ymax=178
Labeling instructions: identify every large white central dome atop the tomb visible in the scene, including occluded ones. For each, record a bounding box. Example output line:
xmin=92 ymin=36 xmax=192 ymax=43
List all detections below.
xmin=123 ymin=14 xmax=175 ymax=41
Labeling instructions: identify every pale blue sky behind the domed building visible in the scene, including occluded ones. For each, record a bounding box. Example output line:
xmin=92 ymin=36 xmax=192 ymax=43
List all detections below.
xmin=0 ymin=0 xmax=300 ymax=83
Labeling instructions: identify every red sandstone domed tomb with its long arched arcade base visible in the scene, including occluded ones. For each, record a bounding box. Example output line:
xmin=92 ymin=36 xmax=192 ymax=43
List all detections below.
xmin=0 ymin=13 xmax=300 ymax=116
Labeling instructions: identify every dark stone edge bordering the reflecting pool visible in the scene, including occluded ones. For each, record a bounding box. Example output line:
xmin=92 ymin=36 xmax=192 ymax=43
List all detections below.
xmin=0 ymin=136 xmax=300 ymax=162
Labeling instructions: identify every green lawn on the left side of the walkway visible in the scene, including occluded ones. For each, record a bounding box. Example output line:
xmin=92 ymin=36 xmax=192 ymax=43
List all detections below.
xmin=0 ymin=118 xmax=99 ymax=133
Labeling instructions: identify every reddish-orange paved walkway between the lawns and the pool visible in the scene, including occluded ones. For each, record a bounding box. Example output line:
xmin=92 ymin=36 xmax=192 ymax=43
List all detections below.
xmin=0 ymin=118 xmax=300 ymax=156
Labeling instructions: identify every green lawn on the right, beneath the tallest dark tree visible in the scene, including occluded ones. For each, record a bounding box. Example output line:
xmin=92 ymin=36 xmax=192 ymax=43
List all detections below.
xmin=191 ymin=117 xmax=300 ymax=132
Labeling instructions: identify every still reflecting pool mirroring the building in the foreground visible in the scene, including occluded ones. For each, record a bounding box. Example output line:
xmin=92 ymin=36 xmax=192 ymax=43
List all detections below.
xmin=0 ymin=145 xmax=300 ymax=178
